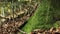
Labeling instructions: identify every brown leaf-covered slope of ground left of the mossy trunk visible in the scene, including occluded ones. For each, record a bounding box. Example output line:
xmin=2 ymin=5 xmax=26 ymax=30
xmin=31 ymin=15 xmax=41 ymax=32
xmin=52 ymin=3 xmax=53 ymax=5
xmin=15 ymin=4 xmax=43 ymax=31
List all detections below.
xmin=0 ymin=0 xmax=38 ymax=34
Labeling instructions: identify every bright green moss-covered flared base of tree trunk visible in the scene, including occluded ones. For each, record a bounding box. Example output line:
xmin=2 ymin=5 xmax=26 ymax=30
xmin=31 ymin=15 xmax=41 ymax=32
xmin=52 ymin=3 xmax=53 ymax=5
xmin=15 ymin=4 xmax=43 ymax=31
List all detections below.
xmin=22 ymin=0 xmax=59 ymax=33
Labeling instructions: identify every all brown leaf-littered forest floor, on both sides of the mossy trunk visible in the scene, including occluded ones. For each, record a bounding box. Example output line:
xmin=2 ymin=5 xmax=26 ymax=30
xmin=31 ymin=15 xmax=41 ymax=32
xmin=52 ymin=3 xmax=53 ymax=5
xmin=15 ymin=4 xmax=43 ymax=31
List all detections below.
xmin=0 ymin=2 xmax=60 ymax=34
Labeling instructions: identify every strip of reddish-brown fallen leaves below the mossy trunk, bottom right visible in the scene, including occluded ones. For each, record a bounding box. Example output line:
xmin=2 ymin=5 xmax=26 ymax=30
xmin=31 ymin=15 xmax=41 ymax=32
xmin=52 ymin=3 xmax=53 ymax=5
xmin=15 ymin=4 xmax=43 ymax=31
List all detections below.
xmin=31 ymin=27 xmax=60 ymax=34
